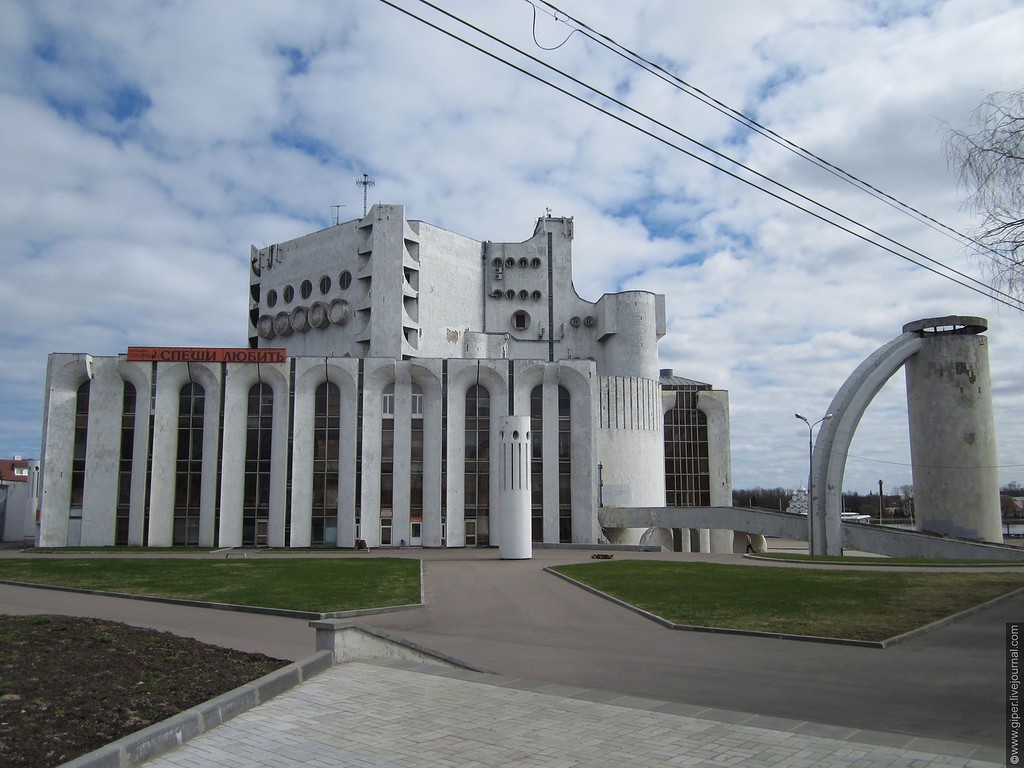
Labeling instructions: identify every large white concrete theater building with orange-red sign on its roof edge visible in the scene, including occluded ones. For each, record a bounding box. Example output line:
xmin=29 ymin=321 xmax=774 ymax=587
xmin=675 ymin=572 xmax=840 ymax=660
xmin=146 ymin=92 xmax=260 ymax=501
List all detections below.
xmin=39 ymin=205 xmax=731 ymax=551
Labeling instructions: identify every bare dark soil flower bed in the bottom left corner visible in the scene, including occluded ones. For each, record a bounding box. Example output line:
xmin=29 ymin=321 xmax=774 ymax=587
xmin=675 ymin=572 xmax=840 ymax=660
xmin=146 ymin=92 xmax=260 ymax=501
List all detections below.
xmin=0 ymin=615 xmax=288 ymax=768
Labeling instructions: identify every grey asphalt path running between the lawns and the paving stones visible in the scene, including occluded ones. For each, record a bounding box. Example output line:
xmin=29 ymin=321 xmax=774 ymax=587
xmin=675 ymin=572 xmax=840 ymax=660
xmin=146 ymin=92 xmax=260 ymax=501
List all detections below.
xmin=0 ymin=550 xmax=1024 ymax=746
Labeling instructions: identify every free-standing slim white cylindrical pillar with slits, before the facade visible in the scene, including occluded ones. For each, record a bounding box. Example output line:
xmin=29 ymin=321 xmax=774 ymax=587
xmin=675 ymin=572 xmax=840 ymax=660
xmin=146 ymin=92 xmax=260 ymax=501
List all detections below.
xmin=498 ymin=416 xmax=534 ymax=560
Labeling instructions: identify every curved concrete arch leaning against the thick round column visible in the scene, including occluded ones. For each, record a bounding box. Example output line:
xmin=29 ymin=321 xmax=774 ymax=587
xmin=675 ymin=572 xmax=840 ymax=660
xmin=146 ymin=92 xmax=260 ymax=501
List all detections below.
xmin=811 ymin=333 xmax=922 ymax=555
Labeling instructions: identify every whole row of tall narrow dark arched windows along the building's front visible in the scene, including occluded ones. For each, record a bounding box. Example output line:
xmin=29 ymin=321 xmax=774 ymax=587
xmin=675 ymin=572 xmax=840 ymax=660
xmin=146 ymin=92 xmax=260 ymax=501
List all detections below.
xmin=71 ymin=382 xmax=571 ymax=547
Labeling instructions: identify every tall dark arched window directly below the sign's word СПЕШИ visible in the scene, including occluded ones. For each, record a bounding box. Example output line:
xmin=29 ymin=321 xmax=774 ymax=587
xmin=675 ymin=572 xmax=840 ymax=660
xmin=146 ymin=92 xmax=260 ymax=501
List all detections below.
xmin=173 ymin=383 xmax=206 ymax=546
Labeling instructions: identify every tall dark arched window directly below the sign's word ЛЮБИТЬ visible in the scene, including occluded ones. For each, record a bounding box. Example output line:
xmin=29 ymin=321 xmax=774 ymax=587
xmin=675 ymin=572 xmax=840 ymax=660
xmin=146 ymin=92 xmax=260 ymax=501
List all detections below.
xmin=242 ymin=384 xmax=273 ymax=547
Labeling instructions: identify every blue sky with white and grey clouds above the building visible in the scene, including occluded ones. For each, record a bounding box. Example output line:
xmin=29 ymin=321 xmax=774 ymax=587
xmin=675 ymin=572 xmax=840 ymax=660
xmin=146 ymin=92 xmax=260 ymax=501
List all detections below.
xmin=0 ymin=0 xmax=1024 ymax=492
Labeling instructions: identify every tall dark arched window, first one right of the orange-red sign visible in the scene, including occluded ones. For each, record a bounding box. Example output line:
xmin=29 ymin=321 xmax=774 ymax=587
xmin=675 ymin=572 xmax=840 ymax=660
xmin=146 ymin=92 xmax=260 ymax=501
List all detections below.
xmin=310 ymin=383 xmax=341 ymax=547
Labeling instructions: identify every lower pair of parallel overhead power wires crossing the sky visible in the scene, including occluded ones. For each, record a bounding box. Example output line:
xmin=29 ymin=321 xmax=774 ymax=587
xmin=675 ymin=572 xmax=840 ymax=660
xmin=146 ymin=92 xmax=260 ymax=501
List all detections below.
xmin=381 ymin=0 xmax=1024 ymax=311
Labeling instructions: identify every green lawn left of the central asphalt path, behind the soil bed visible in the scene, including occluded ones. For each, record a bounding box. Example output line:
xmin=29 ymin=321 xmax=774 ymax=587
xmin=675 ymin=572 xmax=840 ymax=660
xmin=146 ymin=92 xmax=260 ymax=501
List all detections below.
xmin=0 ymin=557 xmax=420 ymax=613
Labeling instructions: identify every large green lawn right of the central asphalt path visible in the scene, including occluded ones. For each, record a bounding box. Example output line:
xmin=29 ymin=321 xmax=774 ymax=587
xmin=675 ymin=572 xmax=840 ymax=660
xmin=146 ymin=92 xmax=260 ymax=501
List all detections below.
xmin=554 ymin=560 xmax=1024 ymax=641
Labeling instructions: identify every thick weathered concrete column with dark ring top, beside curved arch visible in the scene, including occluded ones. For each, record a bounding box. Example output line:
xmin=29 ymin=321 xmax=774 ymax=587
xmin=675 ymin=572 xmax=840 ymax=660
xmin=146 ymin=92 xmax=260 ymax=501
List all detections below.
xmin=903 ymin=316 xmax=1002 ymax=543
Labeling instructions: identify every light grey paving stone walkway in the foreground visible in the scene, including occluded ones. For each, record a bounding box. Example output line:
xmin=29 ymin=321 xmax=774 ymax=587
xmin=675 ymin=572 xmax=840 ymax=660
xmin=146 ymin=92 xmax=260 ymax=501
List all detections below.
xmin=144 ymin=662 xmax=1002 ymax=768
